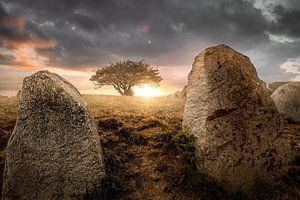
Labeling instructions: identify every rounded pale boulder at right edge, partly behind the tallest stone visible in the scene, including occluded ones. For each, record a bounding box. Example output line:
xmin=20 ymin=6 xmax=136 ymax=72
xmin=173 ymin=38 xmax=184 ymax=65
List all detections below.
xmin=271 ymin=82 xmax=300 ymax=123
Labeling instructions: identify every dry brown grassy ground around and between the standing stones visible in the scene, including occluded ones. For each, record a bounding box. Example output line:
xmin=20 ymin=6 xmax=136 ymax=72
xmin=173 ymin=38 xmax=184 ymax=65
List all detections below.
xmin=0 ymin=95 xmax=300 ymax=200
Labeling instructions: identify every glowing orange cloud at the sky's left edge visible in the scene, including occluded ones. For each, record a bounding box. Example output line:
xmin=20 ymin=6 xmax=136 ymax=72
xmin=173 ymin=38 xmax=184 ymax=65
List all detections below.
xmin=0 ymin=6 xmax=56 ymax=70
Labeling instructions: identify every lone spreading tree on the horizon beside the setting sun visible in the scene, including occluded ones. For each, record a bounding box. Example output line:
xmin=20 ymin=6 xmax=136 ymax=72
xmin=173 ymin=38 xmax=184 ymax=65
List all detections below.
xmin=90 ymin=60 xmax=162 ymax=96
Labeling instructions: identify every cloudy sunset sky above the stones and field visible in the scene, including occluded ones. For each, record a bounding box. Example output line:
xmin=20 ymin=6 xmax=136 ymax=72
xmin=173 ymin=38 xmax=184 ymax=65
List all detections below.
xmin=0 ymin=0 xmax=300 ymax=95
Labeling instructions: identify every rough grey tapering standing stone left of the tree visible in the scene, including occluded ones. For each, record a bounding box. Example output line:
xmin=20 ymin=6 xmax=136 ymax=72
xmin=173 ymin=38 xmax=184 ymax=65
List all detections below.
xmin=3 ymin=71 xmax=105 ymax=200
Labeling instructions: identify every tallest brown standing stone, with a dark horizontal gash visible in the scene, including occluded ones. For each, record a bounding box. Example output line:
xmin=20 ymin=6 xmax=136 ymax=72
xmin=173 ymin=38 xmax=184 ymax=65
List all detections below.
xmin=183 ymin=45 xmax=291 ymax=190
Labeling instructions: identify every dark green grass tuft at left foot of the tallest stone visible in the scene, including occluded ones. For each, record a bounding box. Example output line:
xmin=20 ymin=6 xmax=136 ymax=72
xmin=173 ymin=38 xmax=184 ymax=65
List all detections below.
xmin=164 ymin=128 xmax=226 ymax=199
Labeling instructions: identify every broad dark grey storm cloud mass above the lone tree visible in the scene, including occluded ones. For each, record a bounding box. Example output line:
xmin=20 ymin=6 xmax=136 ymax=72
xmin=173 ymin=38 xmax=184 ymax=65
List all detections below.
xmin=0 ymin=0 xmax=268 ymax=66
